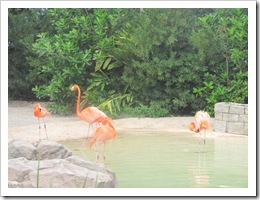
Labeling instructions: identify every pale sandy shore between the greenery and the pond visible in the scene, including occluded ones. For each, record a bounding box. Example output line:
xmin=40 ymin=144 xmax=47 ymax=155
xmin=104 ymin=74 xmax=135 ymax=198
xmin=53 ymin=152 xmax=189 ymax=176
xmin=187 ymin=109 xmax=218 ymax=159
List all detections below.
xmin=8 ymin=101 xmax=247 ymax=142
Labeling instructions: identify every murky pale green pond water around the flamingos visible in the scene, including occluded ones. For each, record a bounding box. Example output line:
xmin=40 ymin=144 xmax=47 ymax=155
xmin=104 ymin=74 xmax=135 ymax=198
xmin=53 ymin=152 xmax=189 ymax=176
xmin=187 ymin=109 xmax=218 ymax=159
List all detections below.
xmin=61 ymin=132 xmax=248 ymax=188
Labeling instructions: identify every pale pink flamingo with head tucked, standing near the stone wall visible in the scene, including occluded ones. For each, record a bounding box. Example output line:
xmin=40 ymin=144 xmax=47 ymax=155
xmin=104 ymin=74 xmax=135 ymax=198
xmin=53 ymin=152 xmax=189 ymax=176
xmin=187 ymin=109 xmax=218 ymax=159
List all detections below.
xmin=189 ymin=111 xmax=210 ymax=144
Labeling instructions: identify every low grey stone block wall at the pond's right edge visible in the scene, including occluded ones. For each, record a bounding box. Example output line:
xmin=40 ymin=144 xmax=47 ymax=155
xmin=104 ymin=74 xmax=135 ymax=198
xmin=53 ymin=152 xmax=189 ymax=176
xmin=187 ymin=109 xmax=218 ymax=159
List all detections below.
xmin=214 ymin=102 xmax=248 ymax=135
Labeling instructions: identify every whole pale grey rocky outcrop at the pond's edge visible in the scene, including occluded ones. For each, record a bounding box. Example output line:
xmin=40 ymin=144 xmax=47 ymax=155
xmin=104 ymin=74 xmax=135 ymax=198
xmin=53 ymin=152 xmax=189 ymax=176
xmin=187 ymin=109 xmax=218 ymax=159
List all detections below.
xmin=8 ymin=139 xmax=117 ymax=188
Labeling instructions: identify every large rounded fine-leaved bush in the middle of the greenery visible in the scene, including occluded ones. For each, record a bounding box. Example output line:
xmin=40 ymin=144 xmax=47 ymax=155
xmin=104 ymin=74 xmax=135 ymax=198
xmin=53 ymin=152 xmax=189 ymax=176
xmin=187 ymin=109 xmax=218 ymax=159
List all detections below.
xmin=114 ymin=9 xmax=212 ymax=114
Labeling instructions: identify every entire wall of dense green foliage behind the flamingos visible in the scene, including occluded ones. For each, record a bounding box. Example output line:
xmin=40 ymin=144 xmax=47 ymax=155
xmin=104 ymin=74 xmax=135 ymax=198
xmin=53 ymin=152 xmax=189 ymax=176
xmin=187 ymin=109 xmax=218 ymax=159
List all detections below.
xmin=9 ymin=8 xmax=248 ymax=117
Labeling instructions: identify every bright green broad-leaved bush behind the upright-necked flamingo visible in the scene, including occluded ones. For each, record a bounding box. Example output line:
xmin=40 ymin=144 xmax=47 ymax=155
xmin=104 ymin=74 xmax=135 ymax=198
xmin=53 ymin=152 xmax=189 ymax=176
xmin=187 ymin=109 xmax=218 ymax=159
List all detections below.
xmin=30 ymin=9 xmax=124 ymax=114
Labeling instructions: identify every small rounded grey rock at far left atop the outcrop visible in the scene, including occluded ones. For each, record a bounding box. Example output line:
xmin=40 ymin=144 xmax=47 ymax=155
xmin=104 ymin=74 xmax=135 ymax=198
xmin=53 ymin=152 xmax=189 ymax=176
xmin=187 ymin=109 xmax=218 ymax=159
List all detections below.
xmin=8 ymin=139 xmax=37 ymax=160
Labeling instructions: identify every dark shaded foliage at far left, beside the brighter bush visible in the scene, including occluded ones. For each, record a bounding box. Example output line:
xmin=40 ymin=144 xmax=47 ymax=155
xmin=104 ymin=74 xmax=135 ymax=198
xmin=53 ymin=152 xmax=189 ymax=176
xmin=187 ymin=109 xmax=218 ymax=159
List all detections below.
xmin=8 ymin=8 xmax=52 ymax=100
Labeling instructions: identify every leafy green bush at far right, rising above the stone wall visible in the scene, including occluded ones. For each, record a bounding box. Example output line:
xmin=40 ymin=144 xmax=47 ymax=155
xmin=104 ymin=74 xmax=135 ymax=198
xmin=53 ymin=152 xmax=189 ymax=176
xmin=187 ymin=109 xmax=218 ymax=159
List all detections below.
xmin=191 ymin=9 xmax=248 ymax=116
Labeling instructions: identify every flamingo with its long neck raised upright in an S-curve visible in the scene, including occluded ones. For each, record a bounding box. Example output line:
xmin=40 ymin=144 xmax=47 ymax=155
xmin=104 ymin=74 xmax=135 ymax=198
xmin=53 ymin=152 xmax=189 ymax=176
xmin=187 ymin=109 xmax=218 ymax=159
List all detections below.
xmin=70 ymin=85 xmax=107 ymax=139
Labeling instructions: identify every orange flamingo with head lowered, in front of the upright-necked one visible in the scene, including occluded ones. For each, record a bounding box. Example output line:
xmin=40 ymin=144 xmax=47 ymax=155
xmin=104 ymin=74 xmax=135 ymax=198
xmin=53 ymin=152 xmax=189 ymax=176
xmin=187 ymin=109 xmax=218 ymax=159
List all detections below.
xmin=88 ymin=117 xmax=117 ymax=162
